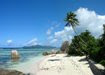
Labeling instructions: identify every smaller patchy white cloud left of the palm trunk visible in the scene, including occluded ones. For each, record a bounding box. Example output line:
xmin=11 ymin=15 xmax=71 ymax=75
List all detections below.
xmin=47 ymin=27 xmax=74 ymax=46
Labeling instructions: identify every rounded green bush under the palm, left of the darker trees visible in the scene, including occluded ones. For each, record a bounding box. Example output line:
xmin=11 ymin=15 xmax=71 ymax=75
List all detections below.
xmin=68 ymin=30 xmax=97 ymax=55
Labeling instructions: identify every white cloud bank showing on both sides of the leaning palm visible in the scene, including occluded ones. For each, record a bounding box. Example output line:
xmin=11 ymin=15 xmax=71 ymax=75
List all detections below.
xmin=50 ymin=8 xmax=105 ymax=44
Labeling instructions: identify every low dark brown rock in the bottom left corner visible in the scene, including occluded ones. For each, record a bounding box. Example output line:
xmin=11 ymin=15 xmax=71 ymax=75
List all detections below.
xmin=0 ymin=69 xmax=25 ymax=75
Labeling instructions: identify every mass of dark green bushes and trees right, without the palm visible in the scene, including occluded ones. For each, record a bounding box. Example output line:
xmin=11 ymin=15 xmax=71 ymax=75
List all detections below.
xmin=68 ymin=25 xmax=105 ymax=66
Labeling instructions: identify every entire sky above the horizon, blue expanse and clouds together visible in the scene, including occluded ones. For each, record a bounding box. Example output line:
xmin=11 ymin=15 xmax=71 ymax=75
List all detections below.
xmin=0 ymin=0 xmax=105 ymax=47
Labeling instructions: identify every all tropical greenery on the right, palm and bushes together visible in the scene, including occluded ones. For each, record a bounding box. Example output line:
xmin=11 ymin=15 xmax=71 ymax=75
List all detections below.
xmin=61 ymin=12 xmax=105 ymax=66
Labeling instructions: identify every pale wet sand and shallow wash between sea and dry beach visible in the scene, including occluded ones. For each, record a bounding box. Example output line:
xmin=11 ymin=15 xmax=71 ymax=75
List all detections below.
xmin=8 ymin=56 xmax=45 ymax=75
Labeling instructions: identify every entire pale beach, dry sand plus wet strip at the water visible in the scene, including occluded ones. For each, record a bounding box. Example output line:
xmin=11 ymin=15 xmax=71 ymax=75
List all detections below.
xmin=9 ymin=54 xmax=93 ymax=75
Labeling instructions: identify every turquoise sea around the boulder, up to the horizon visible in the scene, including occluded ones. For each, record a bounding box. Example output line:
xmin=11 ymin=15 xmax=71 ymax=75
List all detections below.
xmin=0 ymin=48 xmax=52 ymax=68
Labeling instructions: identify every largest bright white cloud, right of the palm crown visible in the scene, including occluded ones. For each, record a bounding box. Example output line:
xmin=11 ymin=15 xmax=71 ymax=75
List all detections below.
xmin=75 ymin=8 xmax=105 ymax=37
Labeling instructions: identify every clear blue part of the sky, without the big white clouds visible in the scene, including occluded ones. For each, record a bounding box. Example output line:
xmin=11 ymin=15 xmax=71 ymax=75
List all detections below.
xmin=0 ymin=0 xmax=105 ymax=46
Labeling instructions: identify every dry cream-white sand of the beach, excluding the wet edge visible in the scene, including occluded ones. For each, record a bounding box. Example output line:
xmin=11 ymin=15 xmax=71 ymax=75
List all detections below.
xmin=37 ymin=54 xmax=93 ymax=75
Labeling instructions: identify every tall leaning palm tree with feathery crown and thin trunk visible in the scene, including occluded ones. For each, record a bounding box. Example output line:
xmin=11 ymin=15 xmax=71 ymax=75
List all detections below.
xmin=65 ymin=12 xmax=87 ymax=54
